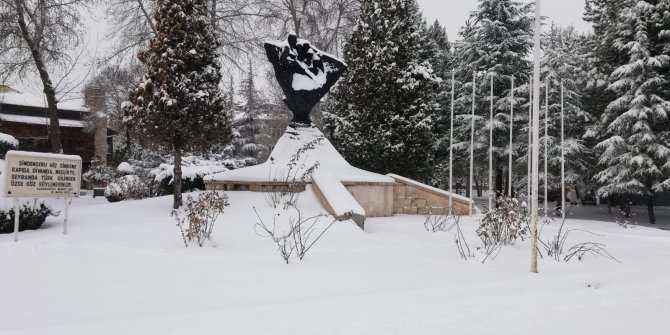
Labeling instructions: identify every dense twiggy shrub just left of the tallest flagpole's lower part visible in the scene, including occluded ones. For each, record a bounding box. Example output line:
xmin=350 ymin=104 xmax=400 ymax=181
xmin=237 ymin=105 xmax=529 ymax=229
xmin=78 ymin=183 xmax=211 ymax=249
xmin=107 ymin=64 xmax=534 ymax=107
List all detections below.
xmin=477 ymin=196 xmax=529 ymax=255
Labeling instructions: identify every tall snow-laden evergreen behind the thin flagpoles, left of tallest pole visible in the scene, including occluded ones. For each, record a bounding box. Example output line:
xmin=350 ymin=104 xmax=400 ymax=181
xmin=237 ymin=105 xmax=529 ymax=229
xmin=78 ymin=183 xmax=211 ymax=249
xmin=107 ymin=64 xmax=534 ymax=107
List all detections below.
xmin=454 ymin=0 xmax=533 ymax=197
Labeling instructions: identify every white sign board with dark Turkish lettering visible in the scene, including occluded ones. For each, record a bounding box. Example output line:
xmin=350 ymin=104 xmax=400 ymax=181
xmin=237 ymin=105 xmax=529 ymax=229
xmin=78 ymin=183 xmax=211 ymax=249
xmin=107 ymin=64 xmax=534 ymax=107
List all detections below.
xmin=4 ymin=150 xmax=81 ymax=198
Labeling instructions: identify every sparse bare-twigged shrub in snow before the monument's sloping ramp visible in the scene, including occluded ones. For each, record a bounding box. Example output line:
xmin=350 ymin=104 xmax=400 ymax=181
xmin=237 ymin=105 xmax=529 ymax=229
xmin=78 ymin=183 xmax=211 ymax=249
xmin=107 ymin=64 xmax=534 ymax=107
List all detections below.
xmin=254 ymin=205 xmax=337 ymax=264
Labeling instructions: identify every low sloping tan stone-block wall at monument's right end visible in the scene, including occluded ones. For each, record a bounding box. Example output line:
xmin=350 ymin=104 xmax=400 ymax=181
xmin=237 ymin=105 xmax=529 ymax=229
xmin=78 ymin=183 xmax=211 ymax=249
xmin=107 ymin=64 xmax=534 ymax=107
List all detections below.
xmin=391 ymin=176 xmax=474 ymax=215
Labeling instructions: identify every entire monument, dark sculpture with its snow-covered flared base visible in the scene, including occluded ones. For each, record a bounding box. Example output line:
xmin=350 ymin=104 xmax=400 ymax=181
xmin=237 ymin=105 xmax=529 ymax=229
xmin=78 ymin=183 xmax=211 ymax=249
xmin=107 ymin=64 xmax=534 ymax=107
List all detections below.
xmin=205 ymin=34 xmax=472 ymax=228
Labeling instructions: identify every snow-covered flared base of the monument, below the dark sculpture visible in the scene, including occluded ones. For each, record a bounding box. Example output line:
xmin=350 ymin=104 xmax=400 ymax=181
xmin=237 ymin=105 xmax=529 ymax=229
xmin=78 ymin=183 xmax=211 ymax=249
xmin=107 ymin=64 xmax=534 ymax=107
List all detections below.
xmin=205 ymin=125 xmax=472 ymax=227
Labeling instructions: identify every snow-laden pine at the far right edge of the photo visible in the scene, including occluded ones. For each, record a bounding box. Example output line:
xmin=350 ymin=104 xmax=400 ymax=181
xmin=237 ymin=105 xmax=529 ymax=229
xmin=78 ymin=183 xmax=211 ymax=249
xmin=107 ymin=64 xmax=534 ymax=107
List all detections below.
xmin=596 ymin=1 xmax=670 ymax=224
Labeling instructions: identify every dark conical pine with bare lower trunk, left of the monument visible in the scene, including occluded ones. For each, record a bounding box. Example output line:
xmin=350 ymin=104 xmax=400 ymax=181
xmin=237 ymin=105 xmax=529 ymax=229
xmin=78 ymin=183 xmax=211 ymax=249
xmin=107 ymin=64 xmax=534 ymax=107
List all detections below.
xmin=125 ymin=0 xmax=231 ymax=208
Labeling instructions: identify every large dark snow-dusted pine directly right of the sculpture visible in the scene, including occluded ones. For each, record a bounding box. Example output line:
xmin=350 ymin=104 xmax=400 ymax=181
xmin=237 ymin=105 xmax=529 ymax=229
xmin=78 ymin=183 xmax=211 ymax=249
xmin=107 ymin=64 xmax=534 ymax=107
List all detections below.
xmin=324 ymin=0 xmax=440 ymax=181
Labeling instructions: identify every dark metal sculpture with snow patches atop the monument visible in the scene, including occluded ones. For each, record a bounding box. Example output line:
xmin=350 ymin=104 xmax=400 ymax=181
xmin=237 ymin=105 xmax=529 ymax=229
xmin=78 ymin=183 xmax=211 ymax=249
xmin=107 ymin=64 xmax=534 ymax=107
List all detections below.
xmin=265 ymin=34 xmax=347 ymax=126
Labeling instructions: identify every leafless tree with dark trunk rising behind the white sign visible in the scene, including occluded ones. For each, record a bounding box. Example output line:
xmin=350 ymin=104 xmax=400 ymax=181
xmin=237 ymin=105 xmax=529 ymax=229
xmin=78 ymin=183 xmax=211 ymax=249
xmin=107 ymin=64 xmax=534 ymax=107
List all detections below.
xmin=0 ymin=0 xmax=86 ymax=153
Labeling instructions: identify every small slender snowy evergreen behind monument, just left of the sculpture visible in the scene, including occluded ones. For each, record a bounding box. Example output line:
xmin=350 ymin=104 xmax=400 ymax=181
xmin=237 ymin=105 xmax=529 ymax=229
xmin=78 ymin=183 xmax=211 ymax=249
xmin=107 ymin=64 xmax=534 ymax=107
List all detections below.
xmin=232 ymin=62 xmax=267 ymax=165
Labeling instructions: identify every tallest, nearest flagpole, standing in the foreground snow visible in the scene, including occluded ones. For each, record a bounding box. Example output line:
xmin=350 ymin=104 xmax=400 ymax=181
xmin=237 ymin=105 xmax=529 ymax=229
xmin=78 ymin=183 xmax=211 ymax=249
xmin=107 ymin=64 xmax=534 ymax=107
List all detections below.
xmin=530 ymin=0 xmax=542 ymax=273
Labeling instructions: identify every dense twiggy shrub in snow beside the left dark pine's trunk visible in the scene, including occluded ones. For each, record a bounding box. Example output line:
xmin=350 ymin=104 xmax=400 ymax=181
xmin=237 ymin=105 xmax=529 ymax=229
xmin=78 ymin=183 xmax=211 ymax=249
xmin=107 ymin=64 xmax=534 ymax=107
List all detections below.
xmin=172 ymin=191 xmax=228 ymax=247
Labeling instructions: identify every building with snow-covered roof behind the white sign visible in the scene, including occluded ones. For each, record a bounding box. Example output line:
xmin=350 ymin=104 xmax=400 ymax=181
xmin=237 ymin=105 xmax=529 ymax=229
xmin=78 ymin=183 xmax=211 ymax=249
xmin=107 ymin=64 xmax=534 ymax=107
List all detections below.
xmin=0 ymin=85 xmax=115 ymax=171
